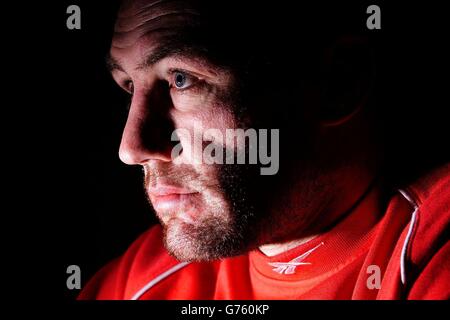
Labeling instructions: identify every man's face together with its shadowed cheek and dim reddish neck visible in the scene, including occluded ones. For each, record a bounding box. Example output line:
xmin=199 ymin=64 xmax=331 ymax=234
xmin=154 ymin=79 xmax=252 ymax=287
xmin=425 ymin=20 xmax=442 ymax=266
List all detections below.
xmin=109 ymin=0 xmax=345 ymax=260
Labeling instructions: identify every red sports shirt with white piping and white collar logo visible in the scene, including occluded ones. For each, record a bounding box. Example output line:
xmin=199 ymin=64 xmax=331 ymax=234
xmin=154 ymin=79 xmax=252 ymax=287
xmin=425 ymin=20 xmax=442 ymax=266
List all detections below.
xmin=79 ymin=165 xmax=450 ymax=299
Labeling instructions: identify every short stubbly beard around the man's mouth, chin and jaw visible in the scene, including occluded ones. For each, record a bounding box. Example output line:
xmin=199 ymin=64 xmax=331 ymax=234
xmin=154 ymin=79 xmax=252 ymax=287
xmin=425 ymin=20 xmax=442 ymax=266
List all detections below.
xmin=144 ymin=163 xmax=262 ymax=261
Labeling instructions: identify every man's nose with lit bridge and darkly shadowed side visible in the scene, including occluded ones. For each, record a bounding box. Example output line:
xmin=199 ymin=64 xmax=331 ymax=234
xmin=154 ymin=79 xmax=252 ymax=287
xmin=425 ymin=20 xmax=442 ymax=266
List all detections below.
xmin=119 ymin=88 xmax=174 ymax=165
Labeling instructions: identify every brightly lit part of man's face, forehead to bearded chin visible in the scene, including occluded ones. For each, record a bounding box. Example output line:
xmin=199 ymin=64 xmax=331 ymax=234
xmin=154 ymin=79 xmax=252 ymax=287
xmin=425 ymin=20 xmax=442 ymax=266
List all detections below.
xmin=110 ymin=1 xmax=264 ymax=260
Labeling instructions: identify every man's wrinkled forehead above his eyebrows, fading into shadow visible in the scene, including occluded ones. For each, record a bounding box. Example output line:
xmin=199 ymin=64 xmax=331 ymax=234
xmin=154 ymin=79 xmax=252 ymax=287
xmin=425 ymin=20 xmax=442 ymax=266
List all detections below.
xmin=110 ymin=0 xmax=212 ymax=69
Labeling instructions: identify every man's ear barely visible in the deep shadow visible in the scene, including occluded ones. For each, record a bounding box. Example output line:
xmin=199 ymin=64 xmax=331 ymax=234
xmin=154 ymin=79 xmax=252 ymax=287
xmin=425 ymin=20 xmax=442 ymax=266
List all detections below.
xmin=319 ymin=37 xmax=375 ymax=126
